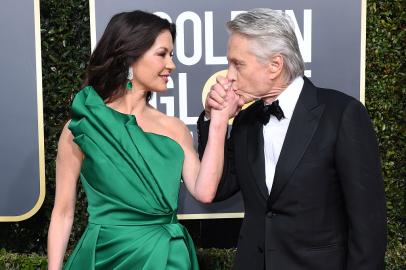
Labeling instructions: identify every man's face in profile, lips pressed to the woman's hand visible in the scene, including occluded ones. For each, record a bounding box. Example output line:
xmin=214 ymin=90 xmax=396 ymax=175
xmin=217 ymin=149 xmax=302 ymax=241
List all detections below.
xmin=227 ymin=33 xmax=272 ymax=96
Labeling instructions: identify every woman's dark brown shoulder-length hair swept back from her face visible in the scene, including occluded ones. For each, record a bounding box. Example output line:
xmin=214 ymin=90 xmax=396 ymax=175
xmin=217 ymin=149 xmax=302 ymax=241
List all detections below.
xmin=84 ymin=10 xmax=176 ymax=102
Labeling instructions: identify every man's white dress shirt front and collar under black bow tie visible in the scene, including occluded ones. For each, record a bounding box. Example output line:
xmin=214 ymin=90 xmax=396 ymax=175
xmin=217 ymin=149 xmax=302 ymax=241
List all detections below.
xmin=262 ymin=77 xmax=304 ymax=193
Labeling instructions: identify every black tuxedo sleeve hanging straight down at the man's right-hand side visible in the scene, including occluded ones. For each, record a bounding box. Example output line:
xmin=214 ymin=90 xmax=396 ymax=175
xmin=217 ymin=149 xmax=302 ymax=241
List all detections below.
xmin=336 ymin=100 xmax=387 ymax=270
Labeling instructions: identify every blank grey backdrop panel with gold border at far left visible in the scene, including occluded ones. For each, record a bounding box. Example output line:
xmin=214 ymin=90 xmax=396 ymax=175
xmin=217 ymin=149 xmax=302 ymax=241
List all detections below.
xmin=0 ymin=0 xmax=45 ymax=221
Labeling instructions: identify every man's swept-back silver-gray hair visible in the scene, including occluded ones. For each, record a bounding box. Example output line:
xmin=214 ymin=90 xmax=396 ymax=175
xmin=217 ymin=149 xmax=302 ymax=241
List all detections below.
xmin=227 ymin=8 xmax=304 ymax=83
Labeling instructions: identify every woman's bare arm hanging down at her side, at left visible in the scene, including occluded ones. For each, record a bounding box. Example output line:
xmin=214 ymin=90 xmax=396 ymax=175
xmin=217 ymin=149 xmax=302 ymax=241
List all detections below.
xmin=48 ymin=122 xmax=83 ymax=270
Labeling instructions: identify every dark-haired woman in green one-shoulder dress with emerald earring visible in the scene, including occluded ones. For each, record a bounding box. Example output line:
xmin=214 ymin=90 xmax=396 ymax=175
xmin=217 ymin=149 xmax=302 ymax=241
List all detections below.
xmin=48 ymin=11 xmax=238 ymax=270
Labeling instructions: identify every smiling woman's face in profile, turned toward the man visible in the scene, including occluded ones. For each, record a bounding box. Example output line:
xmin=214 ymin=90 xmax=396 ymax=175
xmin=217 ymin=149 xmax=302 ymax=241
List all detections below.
xmin=132 ymin=30 xmax=175 ymax=92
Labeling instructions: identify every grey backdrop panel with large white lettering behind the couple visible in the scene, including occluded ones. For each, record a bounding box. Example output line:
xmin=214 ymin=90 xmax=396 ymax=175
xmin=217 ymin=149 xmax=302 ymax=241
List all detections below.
xmin=90 ymin=0 xmax=366 ymax=219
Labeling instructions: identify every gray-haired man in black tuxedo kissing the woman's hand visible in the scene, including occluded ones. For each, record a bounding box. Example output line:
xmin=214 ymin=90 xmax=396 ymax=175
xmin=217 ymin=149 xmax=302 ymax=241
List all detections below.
xmin=198 ymin=9 xmax=386 ymax=270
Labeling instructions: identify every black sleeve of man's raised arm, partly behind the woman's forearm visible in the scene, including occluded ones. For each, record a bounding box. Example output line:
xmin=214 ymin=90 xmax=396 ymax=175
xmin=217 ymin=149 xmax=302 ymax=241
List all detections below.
xmin=197 ymin=112 xmax=240 ymax=201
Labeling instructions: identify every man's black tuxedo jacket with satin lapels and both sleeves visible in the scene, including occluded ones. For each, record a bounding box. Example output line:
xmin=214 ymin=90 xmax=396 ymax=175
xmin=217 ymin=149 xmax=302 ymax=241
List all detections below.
xmin=198 ymin=78 xmax=386 ymax=270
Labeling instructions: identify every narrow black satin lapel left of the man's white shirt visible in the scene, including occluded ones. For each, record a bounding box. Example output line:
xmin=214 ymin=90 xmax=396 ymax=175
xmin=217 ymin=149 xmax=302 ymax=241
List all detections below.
xmin=246 ymin=105 xmax=268 ymax=200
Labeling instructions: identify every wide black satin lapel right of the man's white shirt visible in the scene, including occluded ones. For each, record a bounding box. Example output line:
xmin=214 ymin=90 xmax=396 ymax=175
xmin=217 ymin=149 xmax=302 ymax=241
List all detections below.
xmin=269 ymin=78 xmax=324 ymax=204
